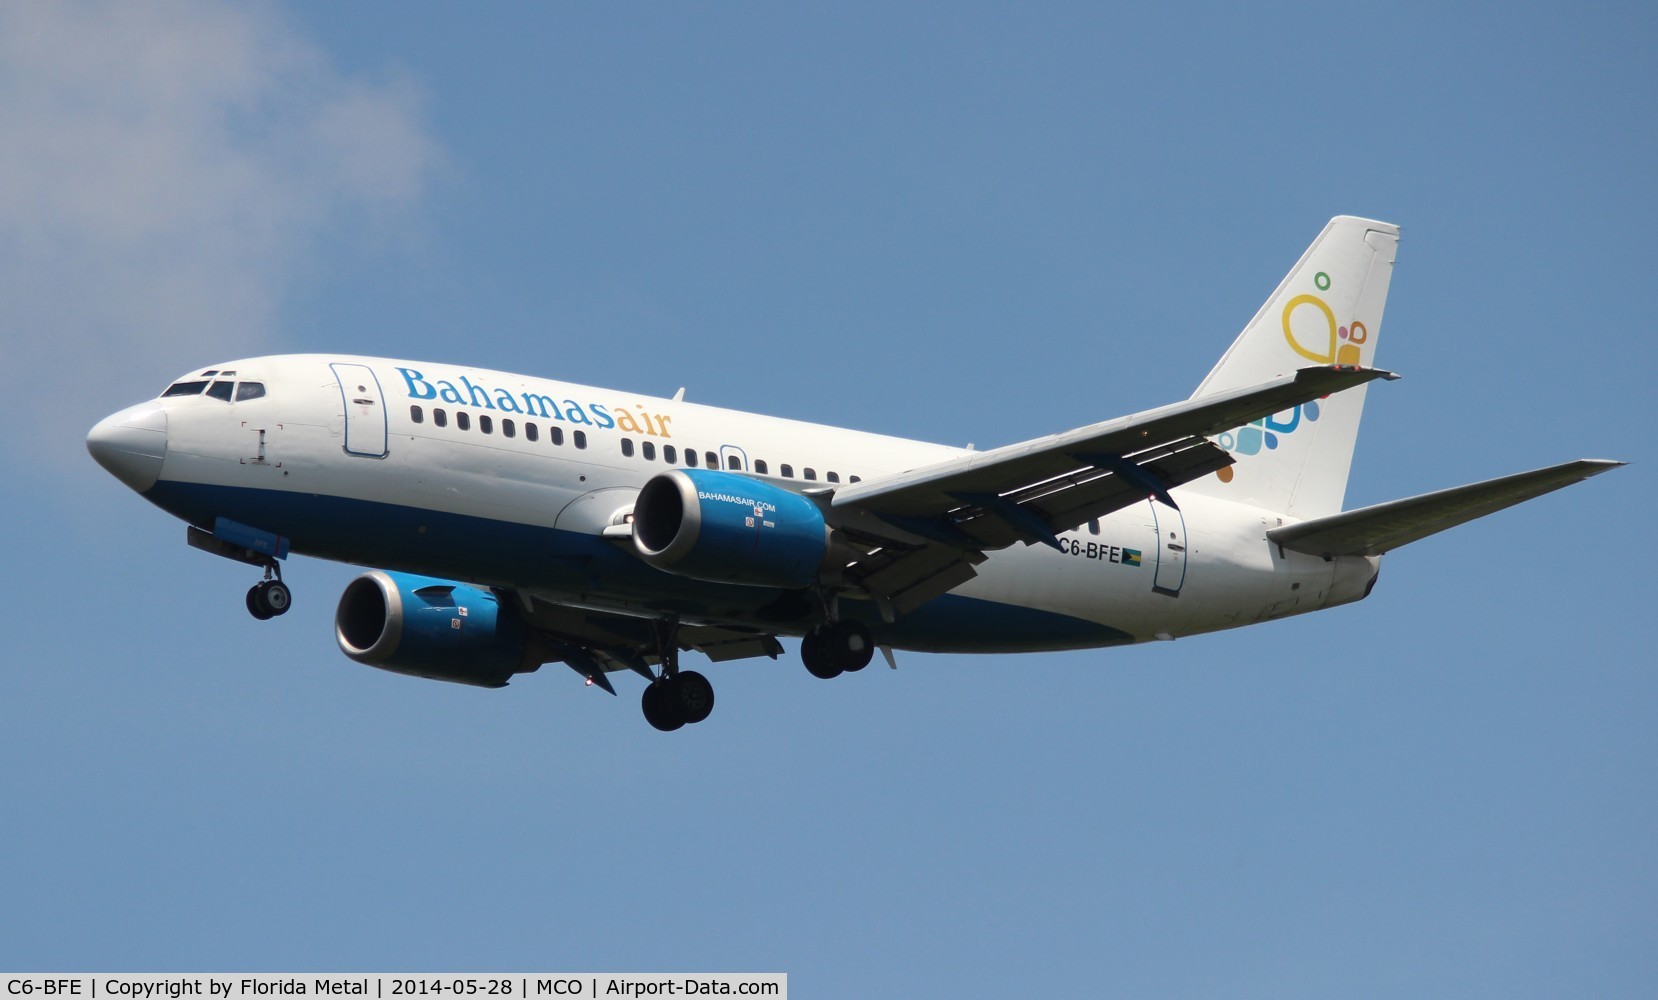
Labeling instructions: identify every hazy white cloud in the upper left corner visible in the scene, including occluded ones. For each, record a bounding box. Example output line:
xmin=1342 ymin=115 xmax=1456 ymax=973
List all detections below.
xmin=0 ymin=0 xmax=441 ymax=463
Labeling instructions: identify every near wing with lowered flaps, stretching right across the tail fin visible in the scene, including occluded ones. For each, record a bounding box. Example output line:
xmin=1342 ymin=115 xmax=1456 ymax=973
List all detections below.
xmin=819 ymin=365 xmax=1398 ymax=610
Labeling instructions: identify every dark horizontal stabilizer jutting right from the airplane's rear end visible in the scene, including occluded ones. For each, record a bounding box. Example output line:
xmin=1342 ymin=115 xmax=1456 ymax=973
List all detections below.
xmin=1267 ymin=458 xmax=1625 ymax=559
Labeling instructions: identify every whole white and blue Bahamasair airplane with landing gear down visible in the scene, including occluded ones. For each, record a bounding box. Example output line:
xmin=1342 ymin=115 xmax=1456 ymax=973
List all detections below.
xmin=86 ymin=216 xmax=1625 ymax=731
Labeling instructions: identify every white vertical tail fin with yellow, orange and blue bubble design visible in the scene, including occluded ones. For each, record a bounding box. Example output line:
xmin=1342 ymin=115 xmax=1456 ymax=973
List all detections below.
xmin=1184 ymin=216 xmax=1399 ymax=517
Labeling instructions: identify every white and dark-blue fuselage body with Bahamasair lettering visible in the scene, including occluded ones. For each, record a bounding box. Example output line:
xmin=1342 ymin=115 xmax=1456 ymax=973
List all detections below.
xmin=96 ymin=355 xmax=1378 ymax=650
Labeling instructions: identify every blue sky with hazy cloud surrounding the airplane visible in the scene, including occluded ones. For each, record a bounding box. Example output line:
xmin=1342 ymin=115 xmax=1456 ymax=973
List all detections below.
xmin=0 ymin=3 xmax=1658 ymax=997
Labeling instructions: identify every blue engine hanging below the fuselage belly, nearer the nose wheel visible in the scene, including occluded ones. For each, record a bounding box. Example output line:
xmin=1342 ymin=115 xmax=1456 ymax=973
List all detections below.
xmin=333 ymin=569 xmax=541 ymax=688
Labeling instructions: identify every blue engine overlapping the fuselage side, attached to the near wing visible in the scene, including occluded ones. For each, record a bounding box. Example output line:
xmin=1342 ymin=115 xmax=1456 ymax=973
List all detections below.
xmin=633 ymin=469 xmax=829 ymax=589
